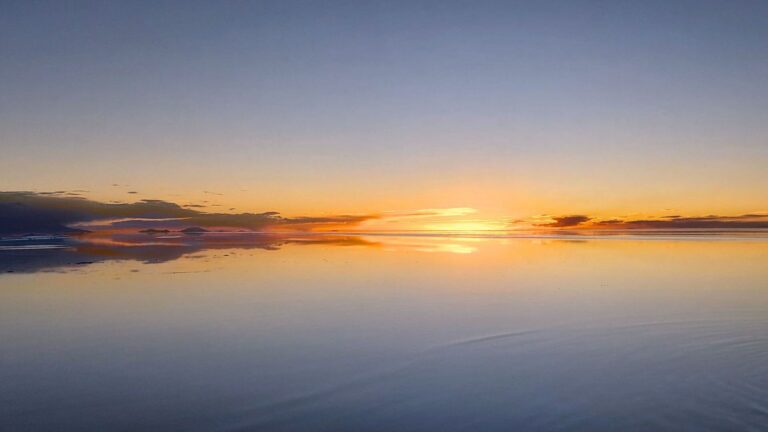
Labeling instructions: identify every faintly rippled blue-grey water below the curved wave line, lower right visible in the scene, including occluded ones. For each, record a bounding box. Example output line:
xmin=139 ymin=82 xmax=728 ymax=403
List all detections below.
xmin=232 ymin=317 xmax=768 ymax=431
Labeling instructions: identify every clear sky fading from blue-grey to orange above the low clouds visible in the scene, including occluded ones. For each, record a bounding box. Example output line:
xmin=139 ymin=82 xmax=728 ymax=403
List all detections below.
xmin=0 ymin=0 xmax=768 ymax=233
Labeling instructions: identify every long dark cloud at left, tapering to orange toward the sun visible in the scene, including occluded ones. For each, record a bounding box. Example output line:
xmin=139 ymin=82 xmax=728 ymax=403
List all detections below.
xmin=0 ymin=192 xmax=378 ymax=234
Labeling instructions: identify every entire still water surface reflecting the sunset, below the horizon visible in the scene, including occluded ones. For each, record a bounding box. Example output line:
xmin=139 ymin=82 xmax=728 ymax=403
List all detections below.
xmin=0 ymin=236 xmax=768 ymax=431
